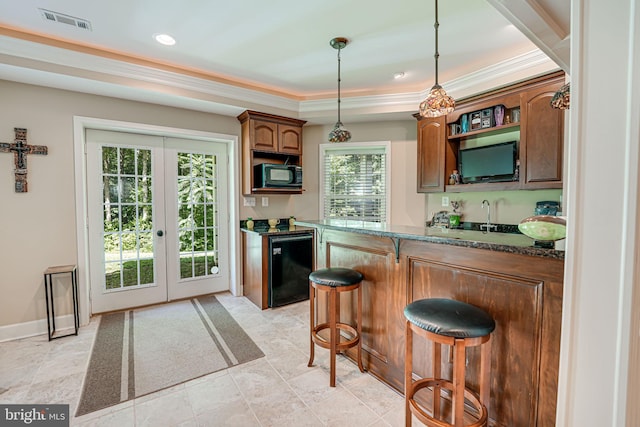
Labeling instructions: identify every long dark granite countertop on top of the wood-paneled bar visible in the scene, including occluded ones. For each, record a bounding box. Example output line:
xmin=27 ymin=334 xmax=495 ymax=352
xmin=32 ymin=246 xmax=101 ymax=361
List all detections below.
xmin=296 ymin=219 xmax=564 ymax=259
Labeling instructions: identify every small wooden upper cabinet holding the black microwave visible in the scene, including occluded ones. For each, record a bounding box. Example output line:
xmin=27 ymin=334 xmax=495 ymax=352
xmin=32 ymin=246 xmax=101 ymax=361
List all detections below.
xmin=238 ymin=110 xmax=306 ymax=195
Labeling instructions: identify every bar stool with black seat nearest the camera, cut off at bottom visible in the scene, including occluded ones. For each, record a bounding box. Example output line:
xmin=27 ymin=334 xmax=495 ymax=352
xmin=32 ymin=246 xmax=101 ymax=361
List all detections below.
xmin=404 ymin=298 xmax=496 ymax=427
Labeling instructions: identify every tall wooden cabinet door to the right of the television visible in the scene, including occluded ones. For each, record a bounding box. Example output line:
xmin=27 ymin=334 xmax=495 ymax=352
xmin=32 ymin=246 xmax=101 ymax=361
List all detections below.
xmin=520 ymin=82 xmax=564 ymax=189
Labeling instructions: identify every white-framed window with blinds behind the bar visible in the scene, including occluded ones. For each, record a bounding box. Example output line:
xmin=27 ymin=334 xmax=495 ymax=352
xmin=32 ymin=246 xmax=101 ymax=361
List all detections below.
xmin=320 ymin=142 xmax=390 ymax=222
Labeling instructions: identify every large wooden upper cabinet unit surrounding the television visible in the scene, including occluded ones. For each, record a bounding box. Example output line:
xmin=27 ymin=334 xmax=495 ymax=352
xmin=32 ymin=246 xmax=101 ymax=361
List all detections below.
xmin=414 ymin=72 xmax=564 ymax=193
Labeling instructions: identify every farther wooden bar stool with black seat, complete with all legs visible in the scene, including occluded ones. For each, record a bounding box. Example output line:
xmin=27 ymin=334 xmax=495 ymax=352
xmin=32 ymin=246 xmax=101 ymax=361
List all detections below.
xmin=308 ymin=267 xmax=364 ymax=387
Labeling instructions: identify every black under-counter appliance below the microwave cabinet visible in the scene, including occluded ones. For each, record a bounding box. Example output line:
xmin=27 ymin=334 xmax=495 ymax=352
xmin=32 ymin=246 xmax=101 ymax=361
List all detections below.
xmin=269 ymin=232 xmax=313 ymax=307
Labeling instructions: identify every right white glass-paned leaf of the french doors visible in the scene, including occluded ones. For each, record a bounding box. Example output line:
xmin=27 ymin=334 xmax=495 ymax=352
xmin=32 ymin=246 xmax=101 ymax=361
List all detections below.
xmin=165 ymin=138 xmax=230 ymax=299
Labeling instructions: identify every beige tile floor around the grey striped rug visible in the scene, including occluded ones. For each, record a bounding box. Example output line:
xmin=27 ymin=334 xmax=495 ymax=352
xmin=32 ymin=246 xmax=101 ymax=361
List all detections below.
xmin=0 ymin=293 xmax=410 ymax=427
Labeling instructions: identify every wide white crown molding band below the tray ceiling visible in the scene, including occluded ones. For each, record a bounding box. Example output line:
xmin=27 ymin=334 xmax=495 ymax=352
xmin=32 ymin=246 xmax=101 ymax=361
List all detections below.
xmin=0 ymin=35 xmax=558 ymax=123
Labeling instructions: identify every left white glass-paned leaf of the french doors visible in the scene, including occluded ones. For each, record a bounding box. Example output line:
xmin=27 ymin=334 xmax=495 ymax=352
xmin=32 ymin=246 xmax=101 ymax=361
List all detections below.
xmin=86 ymin=129 xmax=167 ymax=313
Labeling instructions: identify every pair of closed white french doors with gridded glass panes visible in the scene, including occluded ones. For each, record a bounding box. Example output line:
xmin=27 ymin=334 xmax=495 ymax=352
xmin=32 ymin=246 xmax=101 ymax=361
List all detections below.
xmin=86 ymin=129 xmax=229 ymax=313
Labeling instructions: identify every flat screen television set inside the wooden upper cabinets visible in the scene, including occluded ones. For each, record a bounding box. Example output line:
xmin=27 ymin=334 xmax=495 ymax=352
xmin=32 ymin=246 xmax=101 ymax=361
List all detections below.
xmin=458 ymin=141 xmax=518 ymax=184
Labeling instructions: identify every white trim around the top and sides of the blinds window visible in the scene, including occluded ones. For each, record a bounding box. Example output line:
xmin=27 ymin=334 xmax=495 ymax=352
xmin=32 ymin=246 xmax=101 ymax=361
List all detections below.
xmin=318 ymin=141 xmax=391 ymax=224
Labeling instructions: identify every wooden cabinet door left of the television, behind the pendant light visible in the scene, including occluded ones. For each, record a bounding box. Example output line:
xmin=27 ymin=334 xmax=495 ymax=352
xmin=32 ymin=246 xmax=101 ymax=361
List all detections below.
xmin=417 ymin=116 xmax=447 ymax=193
